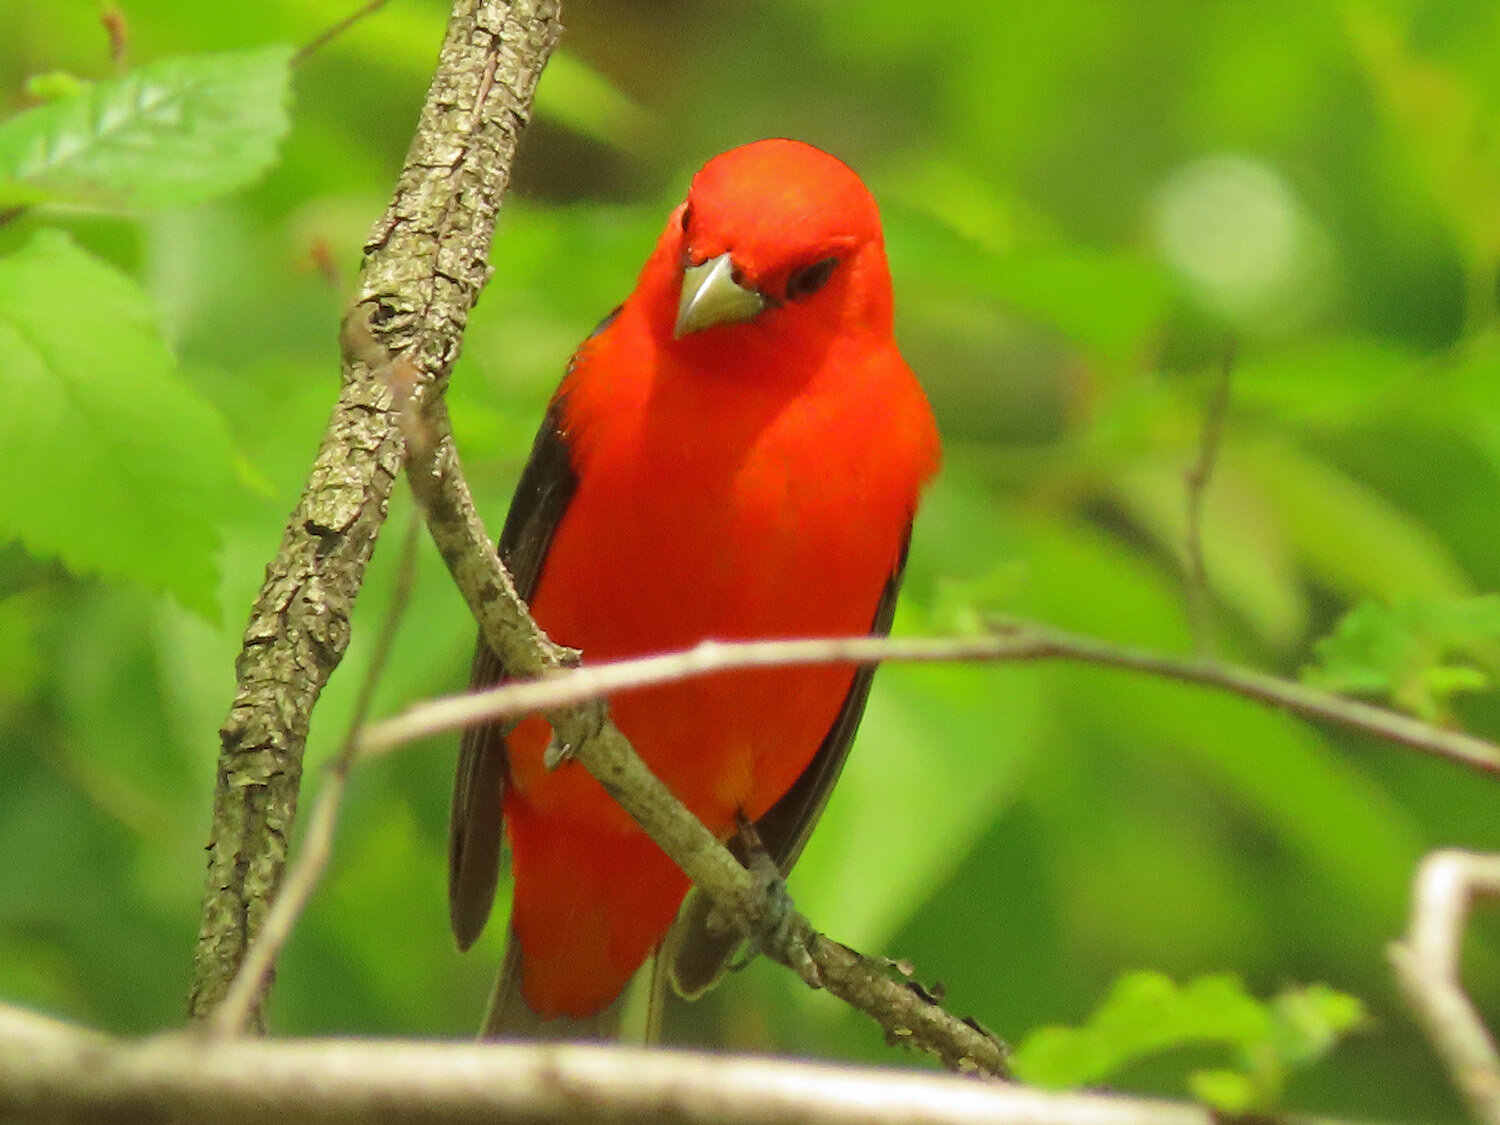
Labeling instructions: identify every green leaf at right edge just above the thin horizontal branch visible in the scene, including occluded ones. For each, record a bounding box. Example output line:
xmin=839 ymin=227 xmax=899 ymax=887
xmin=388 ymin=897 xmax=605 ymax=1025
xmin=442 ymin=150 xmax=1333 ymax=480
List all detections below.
xmin=1302 ymin=594 xmax=1500 ymax=720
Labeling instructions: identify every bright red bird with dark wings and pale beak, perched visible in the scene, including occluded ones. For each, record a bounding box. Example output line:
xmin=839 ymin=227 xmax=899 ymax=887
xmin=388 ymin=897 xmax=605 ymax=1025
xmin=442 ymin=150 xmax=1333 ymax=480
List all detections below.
xmin=449 ymin=140 xmax=939 ymax=1034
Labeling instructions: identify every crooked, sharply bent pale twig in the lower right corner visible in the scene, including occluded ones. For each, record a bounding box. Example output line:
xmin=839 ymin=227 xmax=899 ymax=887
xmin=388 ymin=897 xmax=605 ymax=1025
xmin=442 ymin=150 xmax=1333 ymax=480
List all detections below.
xmin=1389 ymin=851 xmax=1500 ymax=1125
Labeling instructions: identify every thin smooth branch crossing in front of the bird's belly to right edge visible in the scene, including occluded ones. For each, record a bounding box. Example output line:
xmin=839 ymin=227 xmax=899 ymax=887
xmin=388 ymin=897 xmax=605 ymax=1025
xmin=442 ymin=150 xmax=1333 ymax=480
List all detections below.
xmin=363 ymin=623 xmax=1500 ymax=776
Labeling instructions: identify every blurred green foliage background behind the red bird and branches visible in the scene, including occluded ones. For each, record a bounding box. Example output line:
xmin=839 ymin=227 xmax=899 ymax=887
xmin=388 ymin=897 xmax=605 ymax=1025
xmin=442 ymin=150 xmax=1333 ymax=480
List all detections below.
xmin=0 ymin=0 xmax=1500 ymax=1121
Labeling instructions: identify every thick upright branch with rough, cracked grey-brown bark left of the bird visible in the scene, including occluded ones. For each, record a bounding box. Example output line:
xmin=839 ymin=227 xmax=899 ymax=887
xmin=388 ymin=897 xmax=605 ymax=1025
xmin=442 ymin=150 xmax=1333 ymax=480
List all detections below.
xmin=189 ymin=0 xmax=560 ymax=1023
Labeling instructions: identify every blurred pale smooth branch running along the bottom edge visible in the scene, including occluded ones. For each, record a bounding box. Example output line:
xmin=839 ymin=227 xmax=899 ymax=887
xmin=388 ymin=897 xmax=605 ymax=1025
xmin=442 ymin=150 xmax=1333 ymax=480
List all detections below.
xmin=0 ymin=1008 xmax=1362 ymax=1125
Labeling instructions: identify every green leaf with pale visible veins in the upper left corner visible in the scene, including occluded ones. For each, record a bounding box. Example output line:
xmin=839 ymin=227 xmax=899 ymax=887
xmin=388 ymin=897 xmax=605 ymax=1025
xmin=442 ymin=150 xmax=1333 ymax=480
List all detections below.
xmin=0 ymin=47 xmax=291 ymax=207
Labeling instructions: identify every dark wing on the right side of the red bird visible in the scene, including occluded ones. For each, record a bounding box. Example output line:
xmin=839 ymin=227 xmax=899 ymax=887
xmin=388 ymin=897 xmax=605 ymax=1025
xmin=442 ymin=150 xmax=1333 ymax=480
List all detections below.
xmin=668 ymin=528 xmax=911 ymax=999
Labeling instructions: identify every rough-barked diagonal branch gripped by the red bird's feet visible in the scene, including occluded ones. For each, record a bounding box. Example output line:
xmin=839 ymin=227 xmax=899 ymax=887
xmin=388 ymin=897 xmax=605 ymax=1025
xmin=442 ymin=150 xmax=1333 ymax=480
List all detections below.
xmin=405 ymin=410 xmax=1007 ymax=1076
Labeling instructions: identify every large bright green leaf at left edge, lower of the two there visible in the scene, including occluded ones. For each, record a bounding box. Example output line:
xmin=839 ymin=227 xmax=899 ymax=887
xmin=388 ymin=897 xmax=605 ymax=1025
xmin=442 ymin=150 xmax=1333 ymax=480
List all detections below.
xmin=0 ymin=231 xmax=233 ymax=615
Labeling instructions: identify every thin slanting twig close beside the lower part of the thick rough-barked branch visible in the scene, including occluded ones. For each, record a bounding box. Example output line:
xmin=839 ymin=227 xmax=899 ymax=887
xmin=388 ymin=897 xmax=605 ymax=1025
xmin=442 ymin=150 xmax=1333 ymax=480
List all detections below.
xmin=207 ymin=512 xmax=422 ymax=1037
